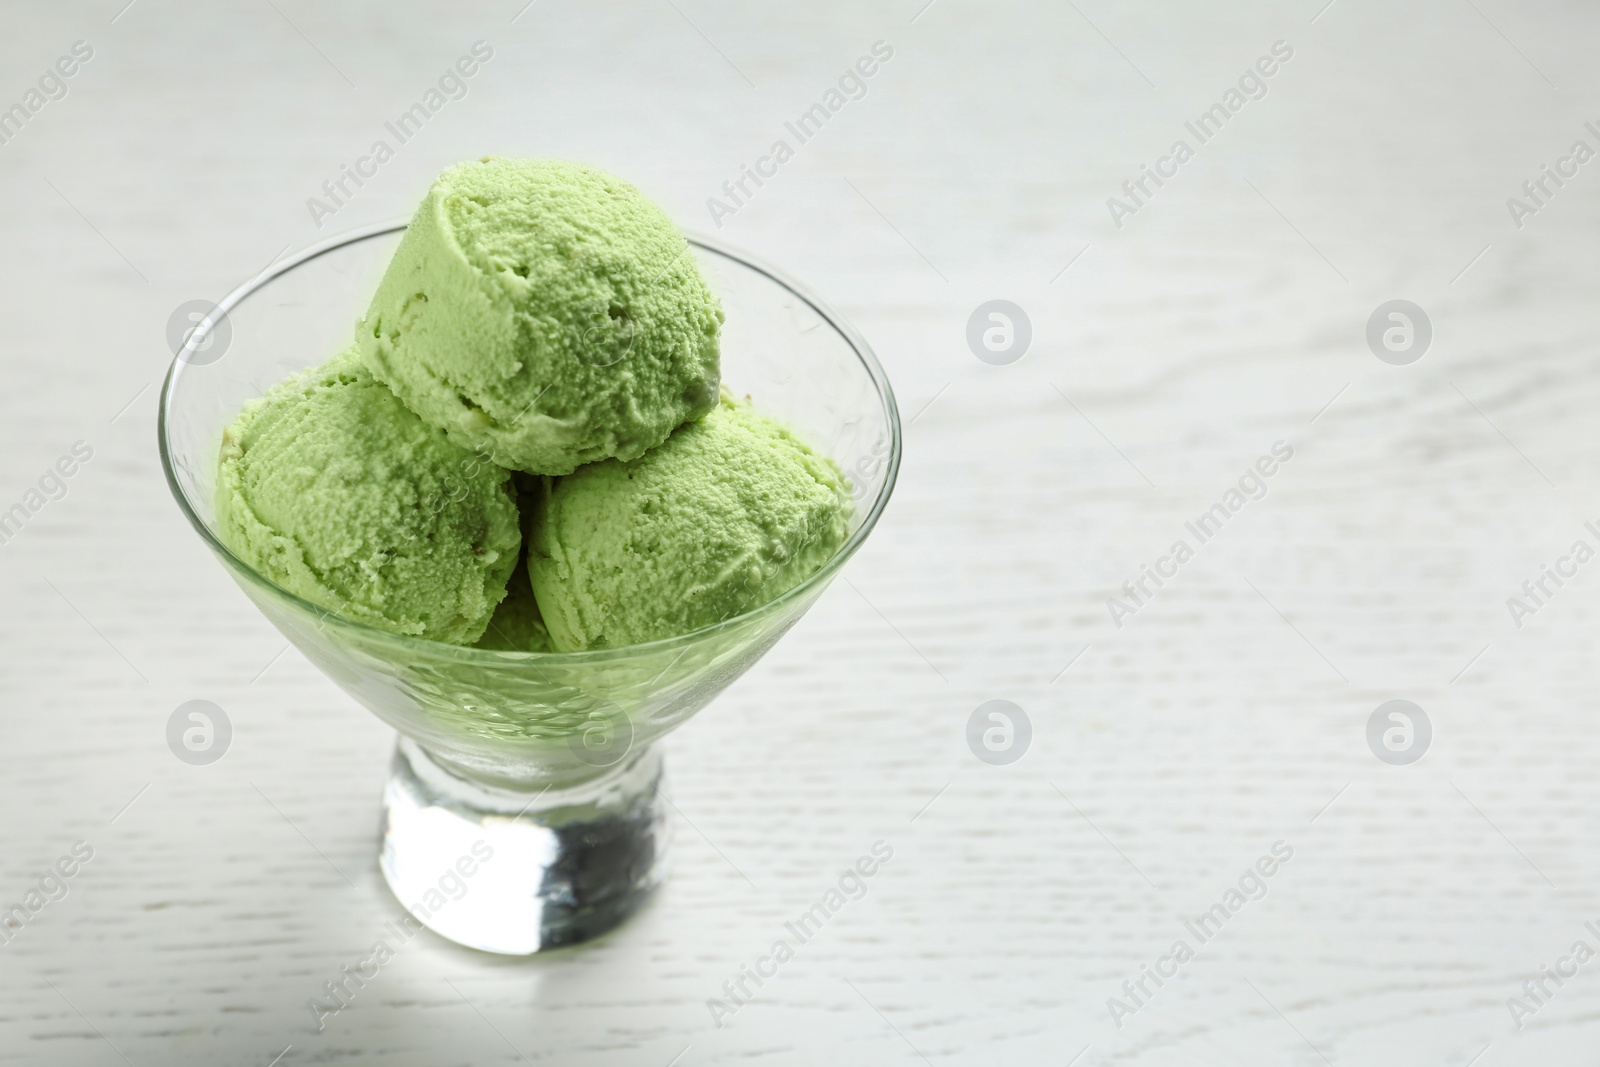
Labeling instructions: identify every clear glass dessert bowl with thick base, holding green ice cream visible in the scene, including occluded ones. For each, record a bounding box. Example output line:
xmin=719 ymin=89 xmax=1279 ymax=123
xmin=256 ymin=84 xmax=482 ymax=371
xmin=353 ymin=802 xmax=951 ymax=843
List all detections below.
xmin=158 ymin=222 xmax=901 ymax=955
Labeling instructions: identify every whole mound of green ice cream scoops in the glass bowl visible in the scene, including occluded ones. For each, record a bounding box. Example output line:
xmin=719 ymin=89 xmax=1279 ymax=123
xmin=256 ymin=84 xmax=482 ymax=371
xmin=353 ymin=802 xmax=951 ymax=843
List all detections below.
xmin=216 ymin=160 xmax=851 ymax=653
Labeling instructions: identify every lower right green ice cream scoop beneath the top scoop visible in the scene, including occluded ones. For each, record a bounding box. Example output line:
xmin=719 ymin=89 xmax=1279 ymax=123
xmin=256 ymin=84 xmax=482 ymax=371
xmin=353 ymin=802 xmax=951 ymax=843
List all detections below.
xmin=528 ymin=394 xmax=851 ymax=651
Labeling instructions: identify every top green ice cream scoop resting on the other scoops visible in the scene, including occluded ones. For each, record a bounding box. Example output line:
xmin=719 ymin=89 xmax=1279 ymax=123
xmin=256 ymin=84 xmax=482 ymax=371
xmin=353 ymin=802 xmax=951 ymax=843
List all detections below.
xmin=355 ymin=158 xmax=722 ymax=475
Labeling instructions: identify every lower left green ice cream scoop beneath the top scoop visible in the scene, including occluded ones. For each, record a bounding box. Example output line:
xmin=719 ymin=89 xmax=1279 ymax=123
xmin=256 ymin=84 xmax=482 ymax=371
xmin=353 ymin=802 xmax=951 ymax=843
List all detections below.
xmin=216 ymin=352 xmax=522 ymax=643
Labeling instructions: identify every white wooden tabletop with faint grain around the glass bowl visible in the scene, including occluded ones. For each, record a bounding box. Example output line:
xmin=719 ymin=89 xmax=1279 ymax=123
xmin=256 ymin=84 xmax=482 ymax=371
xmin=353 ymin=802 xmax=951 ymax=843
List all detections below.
xmin=0 ymin=0 xmax=1600 ymax=1067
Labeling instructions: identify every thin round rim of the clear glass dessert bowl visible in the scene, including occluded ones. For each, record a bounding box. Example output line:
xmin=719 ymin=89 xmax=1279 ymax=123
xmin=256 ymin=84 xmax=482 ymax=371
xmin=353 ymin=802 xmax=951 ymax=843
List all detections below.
xmin=155 ymin=218 xmax=901 ymax=664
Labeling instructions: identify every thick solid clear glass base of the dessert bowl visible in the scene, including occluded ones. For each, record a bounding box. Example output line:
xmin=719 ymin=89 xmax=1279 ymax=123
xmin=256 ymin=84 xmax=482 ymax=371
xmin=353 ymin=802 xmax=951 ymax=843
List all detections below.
xmin=379 ymin=736 xmax=669 ymax=955
